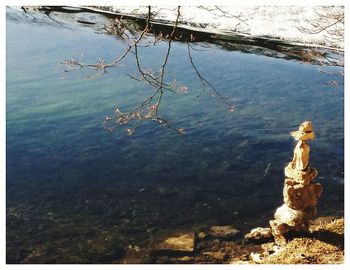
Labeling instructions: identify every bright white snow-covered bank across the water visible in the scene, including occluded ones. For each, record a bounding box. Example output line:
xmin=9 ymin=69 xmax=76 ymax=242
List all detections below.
xmin=103 ymin=6 xmax=344 ymax=49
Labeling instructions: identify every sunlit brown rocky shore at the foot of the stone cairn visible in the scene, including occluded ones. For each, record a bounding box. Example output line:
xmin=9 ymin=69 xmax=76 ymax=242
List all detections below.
xmin=118 ymin=216 xmax=344 ymax=264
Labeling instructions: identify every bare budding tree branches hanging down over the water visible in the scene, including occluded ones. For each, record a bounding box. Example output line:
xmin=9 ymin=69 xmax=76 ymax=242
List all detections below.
xmin=64 ymin=6 xmax=234 ymax=135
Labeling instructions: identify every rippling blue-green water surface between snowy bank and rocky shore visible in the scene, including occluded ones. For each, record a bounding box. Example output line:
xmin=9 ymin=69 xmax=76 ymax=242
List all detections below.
xmin=6 ymin=9 xmax=344 ymax=263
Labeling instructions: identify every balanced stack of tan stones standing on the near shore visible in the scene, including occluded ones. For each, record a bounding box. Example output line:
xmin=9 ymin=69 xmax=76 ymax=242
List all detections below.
xmin=270 ymin=121 xmax=322 ymax=245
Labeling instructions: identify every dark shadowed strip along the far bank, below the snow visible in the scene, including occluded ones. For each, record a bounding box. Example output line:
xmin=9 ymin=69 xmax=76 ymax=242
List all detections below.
xmin=24 ymin=6 xmax=343 ymax=66
